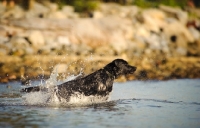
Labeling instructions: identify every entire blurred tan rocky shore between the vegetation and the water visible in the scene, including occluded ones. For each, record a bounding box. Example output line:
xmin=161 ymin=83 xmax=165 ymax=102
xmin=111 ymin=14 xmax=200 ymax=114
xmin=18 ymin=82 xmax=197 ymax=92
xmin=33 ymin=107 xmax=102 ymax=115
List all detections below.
xmin=0 ymin=3 xmax=200 ymax=82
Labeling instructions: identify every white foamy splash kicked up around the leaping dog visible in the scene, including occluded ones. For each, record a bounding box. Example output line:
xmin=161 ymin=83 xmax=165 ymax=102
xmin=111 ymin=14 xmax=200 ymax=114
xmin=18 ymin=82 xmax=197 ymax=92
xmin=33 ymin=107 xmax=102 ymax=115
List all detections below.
xmin=22 ymin=70 xmax=108 ymax=106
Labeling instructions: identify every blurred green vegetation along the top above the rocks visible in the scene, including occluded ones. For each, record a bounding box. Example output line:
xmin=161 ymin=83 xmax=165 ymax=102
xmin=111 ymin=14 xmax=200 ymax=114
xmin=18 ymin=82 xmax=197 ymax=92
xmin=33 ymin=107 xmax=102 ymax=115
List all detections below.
xmin=0 ymin=0 xmax=200 ymax=12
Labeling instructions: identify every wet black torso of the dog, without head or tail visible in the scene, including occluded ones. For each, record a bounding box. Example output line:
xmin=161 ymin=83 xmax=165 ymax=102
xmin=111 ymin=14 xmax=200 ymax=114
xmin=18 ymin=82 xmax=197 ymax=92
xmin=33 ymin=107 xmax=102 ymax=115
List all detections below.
xmin=57 ymin=69 xmax=114 ymax=99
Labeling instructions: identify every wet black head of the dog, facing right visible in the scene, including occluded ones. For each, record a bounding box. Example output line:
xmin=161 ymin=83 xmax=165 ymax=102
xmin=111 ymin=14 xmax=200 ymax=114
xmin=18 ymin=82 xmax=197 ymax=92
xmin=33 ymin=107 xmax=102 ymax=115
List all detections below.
xmin=107 ymin=59 xmax=136 ymax=77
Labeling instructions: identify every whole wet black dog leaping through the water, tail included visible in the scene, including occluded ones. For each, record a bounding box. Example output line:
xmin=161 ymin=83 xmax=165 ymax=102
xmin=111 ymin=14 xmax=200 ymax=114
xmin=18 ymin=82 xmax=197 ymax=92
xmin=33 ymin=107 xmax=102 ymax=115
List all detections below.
xmin=21 ymin=59 xmax=136 ymax=101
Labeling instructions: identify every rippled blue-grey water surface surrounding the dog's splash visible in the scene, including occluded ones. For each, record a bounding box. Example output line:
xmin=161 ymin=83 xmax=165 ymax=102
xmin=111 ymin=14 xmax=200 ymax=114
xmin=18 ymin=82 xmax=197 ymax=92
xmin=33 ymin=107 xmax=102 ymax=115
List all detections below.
xmin=0 ymin=79 xmax=200 ymax=128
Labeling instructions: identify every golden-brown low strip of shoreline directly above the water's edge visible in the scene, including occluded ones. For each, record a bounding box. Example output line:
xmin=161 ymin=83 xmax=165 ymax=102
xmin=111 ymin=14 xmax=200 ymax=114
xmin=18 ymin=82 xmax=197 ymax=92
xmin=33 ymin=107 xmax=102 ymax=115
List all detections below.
xmin=0 ymin=55 xmax=200 ymax=83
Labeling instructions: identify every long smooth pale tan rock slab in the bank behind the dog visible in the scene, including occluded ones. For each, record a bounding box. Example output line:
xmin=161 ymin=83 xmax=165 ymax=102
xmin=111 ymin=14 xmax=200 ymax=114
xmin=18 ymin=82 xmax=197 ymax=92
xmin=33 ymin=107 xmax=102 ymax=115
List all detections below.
xmin=11 ymin=17 xmax=133 ymax=52
